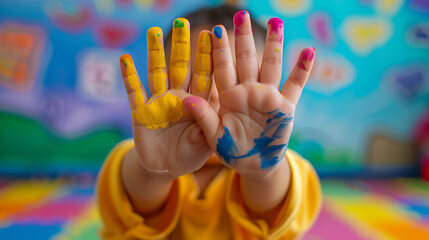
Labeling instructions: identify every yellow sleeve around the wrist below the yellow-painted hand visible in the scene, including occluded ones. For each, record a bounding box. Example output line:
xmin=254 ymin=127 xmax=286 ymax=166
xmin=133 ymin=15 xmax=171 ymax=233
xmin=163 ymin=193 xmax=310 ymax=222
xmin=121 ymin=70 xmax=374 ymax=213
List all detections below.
xmin=97 ymin=140 xmax=182 ymax=239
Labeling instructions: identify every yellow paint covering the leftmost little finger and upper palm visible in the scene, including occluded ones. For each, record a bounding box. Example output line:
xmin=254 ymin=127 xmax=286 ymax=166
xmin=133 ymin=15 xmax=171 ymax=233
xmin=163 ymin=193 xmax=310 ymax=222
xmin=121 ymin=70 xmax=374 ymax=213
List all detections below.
xmin=121 ymin=55 xmax=183 ymax=130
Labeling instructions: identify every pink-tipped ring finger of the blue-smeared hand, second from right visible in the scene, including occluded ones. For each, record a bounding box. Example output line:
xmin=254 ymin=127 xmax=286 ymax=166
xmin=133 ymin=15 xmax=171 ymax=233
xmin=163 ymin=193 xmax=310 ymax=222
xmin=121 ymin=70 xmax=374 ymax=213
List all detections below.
xmin=259 ymin=18 xmax=284 ymax=89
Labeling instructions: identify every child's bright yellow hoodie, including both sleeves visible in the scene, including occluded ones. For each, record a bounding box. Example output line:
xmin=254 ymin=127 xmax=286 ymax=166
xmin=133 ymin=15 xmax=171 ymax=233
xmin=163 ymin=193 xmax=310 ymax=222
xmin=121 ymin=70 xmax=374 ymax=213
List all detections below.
xmin=97 ymin=140 xmax=322 ymax=240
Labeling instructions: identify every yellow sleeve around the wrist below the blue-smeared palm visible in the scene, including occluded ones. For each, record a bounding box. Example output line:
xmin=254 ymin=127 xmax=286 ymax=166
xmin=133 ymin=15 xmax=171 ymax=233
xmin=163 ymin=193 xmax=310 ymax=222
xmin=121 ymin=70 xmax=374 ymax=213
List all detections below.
xmin=226 ymin=150 xmax=322 ymax=239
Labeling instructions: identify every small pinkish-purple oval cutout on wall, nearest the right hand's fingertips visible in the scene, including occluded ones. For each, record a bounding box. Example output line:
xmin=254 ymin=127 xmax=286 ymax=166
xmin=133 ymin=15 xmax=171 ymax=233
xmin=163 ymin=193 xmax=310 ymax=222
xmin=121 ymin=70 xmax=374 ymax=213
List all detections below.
xmin=308 ymin=12 xmax=335 ymax=46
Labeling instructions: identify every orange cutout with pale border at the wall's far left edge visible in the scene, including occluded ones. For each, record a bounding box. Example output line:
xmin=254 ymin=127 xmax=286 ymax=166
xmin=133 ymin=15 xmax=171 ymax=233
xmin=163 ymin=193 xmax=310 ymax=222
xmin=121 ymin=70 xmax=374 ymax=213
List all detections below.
xmin=0 ymin=22 xmax=45 ymax=90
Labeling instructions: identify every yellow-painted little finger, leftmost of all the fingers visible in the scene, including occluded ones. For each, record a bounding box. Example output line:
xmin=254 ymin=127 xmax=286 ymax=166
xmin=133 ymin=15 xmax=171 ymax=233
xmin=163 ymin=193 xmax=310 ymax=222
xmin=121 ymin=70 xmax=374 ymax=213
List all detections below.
xmin=120 ymin=54 xmax=148 ymax=114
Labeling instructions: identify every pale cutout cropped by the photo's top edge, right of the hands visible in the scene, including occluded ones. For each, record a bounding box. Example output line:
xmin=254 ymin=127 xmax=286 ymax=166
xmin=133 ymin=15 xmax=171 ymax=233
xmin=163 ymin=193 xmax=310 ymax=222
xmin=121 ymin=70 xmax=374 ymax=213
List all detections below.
xmin=271 ymin=0 xmax=311 ymax=17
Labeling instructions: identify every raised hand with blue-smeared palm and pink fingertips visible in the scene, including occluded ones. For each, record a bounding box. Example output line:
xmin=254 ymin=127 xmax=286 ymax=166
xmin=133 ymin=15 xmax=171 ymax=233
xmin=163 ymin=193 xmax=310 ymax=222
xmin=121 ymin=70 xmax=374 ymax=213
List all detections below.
xmin=184 ymin=11 xmax=315 ymax=175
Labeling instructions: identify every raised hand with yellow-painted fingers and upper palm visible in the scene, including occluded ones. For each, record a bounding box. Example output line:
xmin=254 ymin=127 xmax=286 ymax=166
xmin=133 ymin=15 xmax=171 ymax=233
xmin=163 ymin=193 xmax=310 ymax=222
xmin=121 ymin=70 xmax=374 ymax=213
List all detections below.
xmin=121 ymin=18 xmax=213 ymax=178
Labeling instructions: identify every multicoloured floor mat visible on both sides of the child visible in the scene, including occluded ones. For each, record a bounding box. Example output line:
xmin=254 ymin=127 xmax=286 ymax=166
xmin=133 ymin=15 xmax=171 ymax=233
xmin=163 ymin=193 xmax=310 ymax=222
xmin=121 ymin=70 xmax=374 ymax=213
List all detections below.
xmin=0 ymin=179 xmax=429 ymax=240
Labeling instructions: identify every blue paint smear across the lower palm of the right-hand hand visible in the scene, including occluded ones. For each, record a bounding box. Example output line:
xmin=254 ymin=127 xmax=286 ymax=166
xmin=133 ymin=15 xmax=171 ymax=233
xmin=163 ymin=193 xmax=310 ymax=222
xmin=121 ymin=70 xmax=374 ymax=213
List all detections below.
xmin=216 ymin=110 xmax=293 ymax=170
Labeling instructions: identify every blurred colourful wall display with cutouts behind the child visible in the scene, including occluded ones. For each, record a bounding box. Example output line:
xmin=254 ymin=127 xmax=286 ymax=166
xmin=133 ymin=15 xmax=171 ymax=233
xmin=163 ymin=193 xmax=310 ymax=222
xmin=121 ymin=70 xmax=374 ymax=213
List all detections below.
xmin=0 ymin=0 xmax=429 ymax=176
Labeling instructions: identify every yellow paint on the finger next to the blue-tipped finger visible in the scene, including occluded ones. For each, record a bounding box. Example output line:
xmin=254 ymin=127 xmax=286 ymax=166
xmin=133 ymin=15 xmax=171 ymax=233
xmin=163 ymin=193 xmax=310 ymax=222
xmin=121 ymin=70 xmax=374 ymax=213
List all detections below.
xmin=194 ymin=32 xmax=213 ymax=93
